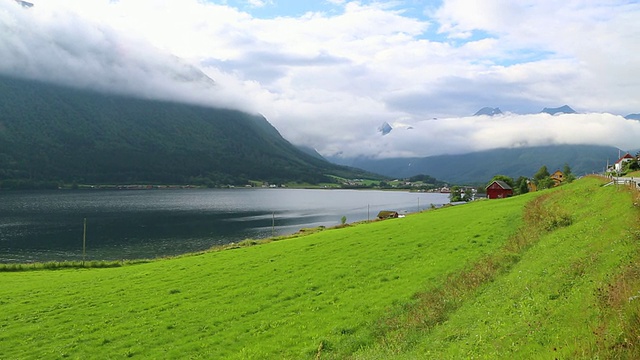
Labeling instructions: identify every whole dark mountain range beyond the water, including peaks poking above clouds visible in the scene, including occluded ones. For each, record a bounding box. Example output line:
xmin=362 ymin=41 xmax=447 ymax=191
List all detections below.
xmin=0 ymin=76 xmax=637 ymax=187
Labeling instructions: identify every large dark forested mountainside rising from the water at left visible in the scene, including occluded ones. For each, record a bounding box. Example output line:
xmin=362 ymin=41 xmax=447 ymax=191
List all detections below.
xmin=0 ymin=77 xmax=376 ymax=185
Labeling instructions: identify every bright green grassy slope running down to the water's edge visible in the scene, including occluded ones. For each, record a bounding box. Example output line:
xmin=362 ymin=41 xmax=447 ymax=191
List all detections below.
xmin=0 ymin=179 xmax=640 ymax=359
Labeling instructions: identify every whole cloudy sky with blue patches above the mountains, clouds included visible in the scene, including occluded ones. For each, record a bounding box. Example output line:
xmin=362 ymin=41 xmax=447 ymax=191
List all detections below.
xmin=0 ymin=0 xmax=640 ymax=158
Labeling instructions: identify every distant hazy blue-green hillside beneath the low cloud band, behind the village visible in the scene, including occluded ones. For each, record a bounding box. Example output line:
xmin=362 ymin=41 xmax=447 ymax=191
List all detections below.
xmin=328 ymin=145 xmax=618 ymax=184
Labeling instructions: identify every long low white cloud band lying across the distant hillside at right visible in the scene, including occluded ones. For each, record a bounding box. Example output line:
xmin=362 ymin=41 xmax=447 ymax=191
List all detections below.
xmin=330 ymin=113 xmax=640 ymax=158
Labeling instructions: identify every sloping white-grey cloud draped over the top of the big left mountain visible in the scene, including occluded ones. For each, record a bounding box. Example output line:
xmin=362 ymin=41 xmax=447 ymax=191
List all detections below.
xmin=0 ymin=2 xmax=255 ymax=111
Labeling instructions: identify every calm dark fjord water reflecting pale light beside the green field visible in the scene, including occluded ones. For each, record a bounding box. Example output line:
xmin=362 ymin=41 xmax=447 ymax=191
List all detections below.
xmin=0 ymin=189 xmax=449 ymax=263
